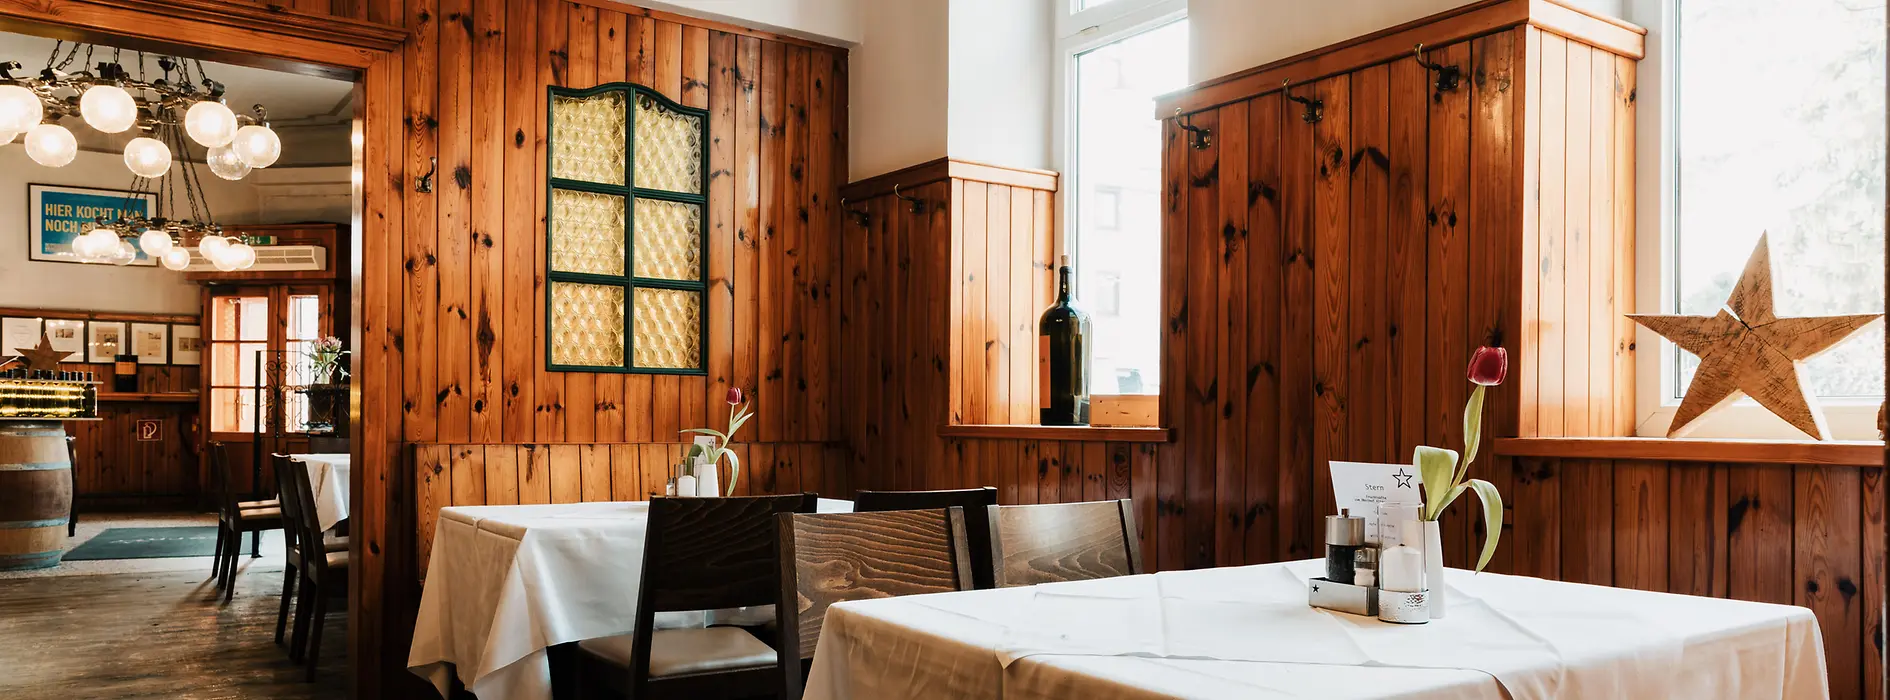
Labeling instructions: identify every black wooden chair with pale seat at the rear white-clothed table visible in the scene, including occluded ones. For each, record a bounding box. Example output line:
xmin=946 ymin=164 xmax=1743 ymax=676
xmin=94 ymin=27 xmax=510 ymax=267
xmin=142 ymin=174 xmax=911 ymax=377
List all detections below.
xmin=576 ymin=494 xmax=818 ymax=700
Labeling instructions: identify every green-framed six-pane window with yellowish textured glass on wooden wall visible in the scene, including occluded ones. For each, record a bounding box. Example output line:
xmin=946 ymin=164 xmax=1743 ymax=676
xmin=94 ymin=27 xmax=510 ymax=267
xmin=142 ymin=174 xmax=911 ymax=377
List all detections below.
xmin=544 ymin=83 xmax=709 ymax=375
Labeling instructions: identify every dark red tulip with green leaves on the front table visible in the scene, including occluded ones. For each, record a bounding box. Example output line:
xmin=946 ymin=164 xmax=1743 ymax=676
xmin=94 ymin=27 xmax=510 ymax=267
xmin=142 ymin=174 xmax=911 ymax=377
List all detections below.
xmin=1412 ymin=346 xmax=1510 ymax=571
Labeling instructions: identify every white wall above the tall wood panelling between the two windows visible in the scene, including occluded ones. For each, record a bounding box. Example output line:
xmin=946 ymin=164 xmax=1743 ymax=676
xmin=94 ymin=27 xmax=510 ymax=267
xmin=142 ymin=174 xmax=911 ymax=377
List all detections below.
xmin=1187 ymin=0 xmax=1622 ymax=83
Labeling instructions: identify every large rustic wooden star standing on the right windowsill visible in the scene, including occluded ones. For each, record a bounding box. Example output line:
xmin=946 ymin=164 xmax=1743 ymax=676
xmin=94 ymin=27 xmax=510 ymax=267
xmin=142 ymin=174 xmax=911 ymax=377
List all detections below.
xmin=1627 ymin=235 xmax=1884 ymax=441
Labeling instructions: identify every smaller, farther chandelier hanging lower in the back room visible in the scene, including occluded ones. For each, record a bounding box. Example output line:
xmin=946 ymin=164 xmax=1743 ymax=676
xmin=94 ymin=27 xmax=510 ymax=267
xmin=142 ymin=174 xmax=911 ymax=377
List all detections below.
xmin=72 ymin=125 xmax=255 ymax=272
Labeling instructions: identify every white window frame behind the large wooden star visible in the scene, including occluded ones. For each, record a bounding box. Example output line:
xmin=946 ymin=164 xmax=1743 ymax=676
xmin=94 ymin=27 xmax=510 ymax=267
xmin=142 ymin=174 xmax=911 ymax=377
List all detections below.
xmin=1625 ymin=0 xmax=1882 ymax=441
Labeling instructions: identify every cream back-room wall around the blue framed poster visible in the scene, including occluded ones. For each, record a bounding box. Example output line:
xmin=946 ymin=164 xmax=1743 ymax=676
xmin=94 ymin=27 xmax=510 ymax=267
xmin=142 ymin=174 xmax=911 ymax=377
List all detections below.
xmin=0 ymin=142 xmax=348 ymax=314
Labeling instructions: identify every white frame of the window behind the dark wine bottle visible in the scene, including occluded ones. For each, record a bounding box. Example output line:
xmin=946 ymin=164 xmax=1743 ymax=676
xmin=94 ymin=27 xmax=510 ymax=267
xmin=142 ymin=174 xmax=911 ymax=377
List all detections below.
xmin=1051 ymin=0 xmax=1193 ymax=399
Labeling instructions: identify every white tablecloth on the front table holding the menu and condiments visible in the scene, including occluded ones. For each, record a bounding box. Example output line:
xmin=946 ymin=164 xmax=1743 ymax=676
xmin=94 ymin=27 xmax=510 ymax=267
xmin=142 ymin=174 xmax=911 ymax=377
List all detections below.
xmin=805 ymin=562 xmax=1830 ymax=700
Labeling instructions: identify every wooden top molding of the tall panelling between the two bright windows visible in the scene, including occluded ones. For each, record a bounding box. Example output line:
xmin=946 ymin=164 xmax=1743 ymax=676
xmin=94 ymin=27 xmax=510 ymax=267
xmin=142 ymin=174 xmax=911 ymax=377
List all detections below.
xmin=1155 ymin=0 xmax=1646 ymax=119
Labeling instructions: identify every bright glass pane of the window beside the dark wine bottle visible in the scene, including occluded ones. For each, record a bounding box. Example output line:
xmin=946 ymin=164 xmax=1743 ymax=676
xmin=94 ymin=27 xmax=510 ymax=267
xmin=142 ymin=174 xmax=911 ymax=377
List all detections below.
xmin=1074 ymin=20 xmax=1187 ymax=394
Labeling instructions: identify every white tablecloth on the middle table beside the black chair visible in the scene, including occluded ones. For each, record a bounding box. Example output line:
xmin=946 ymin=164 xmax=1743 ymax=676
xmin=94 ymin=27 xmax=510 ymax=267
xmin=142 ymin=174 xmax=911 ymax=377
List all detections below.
xmin=417 ymin=498 xmax=852 ymax=700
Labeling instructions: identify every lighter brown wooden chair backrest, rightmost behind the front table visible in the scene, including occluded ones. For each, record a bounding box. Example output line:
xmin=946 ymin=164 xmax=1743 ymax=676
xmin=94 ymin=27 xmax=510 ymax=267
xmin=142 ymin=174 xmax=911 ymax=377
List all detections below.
xmin=990 ymin=498 xmax=1142 ymax=588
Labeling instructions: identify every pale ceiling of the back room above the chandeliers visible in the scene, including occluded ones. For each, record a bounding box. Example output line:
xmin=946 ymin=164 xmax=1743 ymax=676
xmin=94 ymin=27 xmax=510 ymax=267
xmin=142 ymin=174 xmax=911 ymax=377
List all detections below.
xmin=0 ymin=32 xmax=353 ymax=166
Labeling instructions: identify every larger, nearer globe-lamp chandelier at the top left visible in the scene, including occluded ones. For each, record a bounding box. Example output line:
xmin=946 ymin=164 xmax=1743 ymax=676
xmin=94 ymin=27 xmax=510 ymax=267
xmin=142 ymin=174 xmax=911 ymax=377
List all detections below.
xmin=0 ymin=42 xmax=282 ymax=180
